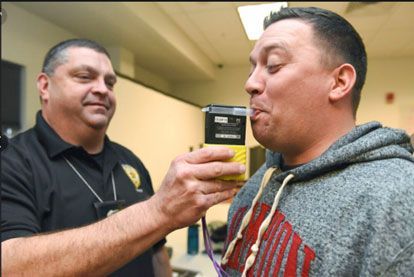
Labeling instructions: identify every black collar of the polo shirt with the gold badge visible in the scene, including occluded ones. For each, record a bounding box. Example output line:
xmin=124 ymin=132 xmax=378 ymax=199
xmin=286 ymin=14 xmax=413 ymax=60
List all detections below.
xmin=35 ymin=111 xmax=109 ymax=159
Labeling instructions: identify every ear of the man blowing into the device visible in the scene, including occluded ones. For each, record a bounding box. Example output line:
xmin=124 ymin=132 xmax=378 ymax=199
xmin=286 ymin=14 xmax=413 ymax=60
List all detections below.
xmin=329 ymin=63 xmax=356 ymax=102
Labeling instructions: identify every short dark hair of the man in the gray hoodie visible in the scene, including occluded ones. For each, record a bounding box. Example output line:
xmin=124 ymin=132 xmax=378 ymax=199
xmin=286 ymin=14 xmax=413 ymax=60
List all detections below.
xmin=263 ymin=7 xmax=367 ymax=117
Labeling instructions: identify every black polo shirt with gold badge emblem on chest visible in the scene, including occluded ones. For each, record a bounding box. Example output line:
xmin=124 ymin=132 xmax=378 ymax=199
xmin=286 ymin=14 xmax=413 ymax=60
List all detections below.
xmin=1 ymin=111 xmax=165 ymax=276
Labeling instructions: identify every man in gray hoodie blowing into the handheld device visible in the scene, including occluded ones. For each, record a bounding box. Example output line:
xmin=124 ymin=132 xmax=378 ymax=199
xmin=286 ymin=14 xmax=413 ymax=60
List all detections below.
xmin=222 ymin=8 xmax=414 ymax=276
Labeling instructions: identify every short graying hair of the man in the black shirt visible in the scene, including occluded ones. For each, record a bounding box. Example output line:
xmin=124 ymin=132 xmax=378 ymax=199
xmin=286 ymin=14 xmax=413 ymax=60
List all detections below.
xmin=42 ymin=38 xmax=111 ymax=76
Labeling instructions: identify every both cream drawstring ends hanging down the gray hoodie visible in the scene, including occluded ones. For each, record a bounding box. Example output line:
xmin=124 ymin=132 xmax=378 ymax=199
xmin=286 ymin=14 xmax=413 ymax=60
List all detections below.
xmin=222 ymin=167 xmax=294 ymax=276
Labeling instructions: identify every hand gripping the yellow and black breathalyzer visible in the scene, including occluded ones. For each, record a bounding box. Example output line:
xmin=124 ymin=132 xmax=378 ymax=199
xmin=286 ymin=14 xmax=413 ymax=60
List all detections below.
xmin=153 ymin=146 xmax=245 ymax=231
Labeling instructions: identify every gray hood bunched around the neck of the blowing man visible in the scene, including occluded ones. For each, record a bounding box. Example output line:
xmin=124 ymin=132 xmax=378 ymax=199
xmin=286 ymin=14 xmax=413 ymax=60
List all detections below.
xmin=266 ymin=121 xmax=414 ymax=181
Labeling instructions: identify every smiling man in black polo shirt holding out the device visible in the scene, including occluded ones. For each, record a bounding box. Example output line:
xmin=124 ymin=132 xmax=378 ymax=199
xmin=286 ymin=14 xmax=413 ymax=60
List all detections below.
xmin=1 ymin=39 xmax=244 ymax=276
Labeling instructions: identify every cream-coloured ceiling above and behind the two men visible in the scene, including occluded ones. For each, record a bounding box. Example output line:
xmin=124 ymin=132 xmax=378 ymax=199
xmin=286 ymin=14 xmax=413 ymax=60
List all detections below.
xmin=15 ymin=2 xmax=414 ymax=82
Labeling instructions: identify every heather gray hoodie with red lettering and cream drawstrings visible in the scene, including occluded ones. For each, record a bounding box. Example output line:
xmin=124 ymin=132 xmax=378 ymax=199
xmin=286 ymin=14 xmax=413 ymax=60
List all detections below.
xmin=222 ymin=122 xmax=414 ymax=276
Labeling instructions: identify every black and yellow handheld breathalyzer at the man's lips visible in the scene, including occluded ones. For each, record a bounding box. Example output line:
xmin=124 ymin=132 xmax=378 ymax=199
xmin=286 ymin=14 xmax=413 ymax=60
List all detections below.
xmin=201 ymin=104 xmax=251 ymax=181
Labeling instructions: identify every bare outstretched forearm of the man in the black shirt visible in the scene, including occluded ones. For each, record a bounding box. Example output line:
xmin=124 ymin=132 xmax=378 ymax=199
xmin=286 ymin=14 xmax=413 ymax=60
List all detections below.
xmin=1 ymin=199 xmax=171 ymax=276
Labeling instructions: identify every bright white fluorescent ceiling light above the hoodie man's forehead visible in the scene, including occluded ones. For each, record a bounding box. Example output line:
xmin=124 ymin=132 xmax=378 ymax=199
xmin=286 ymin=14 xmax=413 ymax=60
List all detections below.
xmin=237 ymin=2 xmax=287 ymax=40
